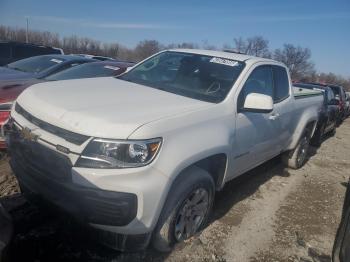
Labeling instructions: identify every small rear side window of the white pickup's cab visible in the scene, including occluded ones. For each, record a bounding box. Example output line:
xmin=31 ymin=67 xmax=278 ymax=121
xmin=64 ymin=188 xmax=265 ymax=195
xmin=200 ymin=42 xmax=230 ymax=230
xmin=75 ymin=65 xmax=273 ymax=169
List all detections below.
xmin=273 ymin=66 xmax=289 ymax=103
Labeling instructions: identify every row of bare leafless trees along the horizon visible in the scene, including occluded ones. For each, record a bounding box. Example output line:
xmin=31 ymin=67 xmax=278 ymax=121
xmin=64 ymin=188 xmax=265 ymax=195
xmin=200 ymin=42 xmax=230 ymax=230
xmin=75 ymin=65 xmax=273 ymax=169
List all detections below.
xmin=0 ymin=25 xmax=350 ymax=91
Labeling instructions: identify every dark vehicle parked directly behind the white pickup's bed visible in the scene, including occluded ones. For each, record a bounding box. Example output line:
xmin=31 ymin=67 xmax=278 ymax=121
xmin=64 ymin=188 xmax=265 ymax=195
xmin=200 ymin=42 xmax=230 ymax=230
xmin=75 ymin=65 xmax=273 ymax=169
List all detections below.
xmin=293 ymin=83 xmax=339 ymax=146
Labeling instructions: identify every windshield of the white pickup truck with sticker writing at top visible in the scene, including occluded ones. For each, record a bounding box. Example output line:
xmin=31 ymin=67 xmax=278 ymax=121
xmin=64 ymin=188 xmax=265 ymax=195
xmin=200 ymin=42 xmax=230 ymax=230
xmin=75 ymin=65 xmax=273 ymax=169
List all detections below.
xmin=119 ymin=51 xmax=244 ymax=103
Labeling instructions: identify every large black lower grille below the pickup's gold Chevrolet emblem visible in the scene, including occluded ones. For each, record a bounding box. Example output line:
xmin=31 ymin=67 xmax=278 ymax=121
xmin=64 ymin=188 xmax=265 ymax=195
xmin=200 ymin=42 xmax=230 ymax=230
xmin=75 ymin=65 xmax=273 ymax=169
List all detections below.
xmin=10 ymin=128 xmax=72 ymax=181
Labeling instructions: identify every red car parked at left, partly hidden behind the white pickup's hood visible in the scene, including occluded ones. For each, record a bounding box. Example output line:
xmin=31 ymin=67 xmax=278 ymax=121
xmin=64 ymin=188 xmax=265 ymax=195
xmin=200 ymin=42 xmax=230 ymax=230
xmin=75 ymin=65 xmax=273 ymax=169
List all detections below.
xmin=0 ymin=61 xmax=134 ymax=149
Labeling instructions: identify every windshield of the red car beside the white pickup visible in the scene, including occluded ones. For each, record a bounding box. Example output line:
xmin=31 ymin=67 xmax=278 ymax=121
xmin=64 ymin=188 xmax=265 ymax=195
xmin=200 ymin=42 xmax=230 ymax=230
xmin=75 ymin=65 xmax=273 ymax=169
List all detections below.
xmin=45 ymin=63 xmax=126 ymax=81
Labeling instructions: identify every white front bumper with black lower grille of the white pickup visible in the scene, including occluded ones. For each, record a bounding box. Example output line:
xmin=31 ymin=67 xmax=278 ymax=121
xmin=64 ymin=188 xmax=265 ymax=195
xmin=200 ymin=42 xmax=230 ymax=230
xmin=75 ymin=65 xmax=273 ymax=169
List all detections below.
xmin=6 ymin=119 xmax=169 ymax=250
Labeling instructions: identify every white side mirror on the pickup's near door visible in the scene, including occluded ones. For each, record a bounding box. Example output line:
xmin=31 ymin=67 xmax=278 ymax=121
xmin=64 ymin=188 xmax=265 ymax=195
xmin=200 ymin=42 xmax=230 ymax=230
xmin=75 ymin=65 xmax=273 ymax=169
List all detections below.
xmin=243 ymin=93 xmax=273 ymax=113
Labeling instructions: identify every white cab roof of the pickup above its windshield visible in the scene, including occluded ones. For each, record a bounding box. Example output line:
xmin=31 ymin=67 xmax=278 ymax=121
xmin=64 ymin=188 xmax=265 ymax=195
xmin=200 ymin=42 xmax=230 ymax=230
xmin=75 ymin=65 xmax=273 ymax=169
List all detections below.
xmin=167 ymin=48 xmax=283 ymax=65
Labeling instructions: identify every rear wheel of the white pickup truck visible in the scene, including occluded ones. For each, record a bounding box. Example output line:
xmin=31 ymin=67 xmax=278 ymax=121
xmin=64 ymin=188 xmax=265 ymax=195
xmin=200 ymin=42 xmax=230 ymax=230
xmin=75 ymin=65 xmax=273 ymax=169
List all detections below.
xmin=282 ymin=131 xmax=310 ymax=169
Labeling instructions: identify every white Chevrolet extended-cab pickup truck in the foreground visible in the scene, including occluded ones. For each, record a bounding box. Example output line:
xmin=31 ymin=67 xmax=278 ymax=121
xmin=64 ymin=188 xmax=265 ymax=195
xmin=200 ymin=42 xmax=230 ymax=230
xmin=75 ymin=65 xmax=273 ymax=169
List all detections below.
xmin=6 ymin=49 xmax=323 ymax=251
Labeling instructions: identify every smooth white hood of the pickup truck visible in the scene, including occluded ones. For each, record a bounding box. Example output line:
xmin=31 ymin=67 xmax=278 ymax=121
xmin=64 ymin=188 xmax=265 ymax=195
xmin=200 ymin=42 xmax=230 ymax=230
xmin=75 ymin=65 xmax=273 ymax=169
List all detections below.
xmin=17 ymin=77 xmax=212 ymax=139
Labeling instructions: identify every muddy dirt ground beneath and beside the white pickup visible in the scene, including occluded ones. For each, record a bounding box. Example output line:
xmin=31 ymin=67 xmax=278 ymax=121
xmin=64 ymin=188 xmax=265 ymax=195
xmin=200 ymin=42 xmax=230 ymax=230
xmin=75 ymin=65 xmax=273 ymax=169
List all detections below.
xmin=0 ymin=119 xmax=350 ymax=262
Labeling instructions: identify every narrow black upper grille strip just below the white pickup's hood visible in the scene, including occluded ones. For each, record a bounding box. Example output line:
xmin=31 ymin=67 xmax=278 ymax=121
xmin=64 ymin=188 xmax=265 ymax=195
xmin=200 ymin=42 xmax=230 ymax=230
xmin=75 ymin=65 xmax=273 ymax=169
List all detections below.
xmin=15 ymin=103 xmax=89 ymax=145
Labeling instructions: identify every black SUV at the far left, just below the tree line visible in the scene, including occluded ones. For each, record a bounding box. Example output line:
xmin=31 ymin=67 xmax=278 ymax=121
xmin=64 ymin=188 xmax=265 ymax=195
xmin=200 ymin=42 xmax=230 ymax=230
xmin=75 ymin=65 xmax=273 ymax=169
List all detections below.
xmin=0 ymin=42 xmax=63 ymax=66
